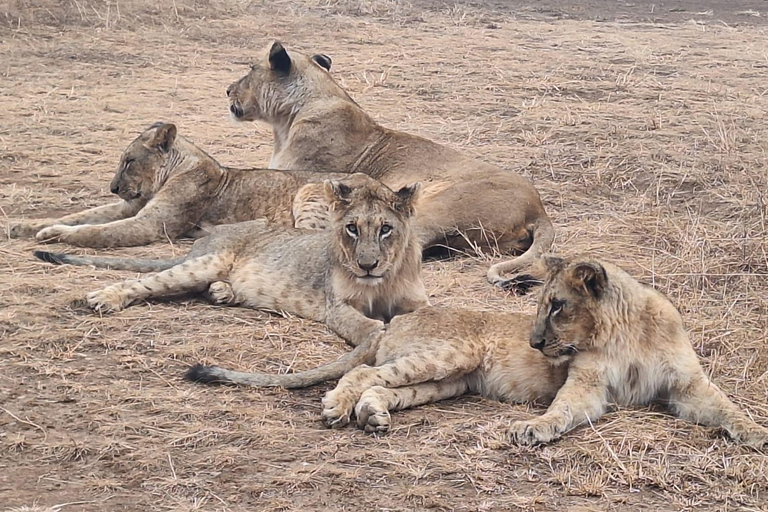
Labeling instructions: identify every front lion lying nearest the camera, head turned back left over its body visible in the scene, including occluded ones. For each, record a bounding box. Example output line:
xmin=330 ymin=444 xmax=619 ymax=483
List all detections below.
xmin=187 ymin=256 xmax=768 ymax=447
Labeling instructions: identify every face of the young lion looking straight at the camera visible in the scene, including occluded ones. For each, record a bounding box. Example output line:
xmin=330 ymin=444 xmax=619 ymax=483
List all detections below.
xmin=325 ymin=179 xmax=420 ymax=286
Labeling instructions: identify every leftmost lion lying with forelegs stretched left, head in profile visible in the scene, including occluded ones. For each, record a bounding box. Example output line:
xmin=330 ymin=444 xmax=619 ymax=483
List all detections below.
xmin=10 ymin=123 xmax=370 ymax=248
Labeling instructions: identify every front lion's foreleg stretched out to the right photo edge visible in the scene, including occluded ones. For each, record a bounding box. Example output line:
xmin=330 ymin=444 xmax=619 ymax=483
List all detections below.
xmin=669 ymin=372 xmax=768 ymax=448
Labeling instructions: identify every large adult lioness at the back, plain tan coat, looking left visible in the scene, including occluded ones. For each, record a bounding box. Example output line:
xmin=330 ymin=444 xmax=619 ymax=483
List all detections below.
xmin=227 ymin=42 xmax=554 ymax=286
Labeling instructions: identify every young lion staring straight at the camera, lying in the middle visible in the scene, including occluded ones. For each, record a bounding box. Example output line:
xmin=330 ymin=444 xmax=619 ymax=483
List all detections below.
xmin=35 ymin=180 xmax=429 ymax=346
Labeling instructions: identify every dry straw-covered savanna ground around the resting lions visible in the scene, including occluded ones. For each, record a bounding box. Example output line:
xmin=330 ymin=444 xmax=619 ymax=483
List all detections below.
xmin=0 ymin=0 xmax=768 ymax=511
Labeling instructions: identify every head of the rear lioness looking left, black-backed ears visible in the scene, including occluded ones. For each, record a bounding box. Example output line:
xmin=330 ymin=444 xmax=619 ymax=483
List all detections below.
xmin=227 ymin=42 xmax=335 ymax=123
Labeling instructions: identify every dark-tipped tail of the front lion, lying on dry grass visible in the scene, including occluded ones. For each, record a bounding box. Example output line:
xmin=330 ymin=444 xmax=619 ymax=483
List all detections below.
xmin=184 ymin=331 xmax=384 ymax=389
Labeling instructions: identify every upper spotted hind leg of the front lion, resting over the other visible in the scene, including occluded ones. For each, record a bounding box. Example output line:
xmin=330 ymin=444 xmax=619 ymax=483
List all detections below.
xmin=323 ymin=348 xmax=483 ymax=428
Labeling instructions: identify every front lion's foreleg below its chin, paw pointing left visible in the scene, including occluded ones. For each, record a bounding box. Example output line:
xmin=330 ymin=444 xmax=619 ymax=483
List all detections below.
xmin=509 ymin=370 xmax=608 ymax=444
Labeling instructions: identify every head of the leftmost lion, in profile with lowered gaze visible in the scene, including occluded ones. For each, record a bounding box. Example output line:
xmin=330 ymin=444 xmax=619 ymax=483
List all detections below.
xmin=109 ymin=123 xmax=176 ymax=201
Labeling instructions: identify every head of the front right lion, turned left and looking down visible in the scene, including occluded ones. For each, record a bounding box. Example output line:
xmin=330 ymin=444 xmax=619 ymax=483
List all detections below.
xmin=530 ymin=256 xmax=608 ymax=360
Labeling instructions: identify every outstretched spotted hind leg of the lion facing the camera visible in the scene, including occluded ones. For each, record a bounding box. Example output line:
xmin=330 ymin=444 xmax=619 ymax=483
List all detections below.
xmin=87 ymin=254 xmax=228 ymax=313
